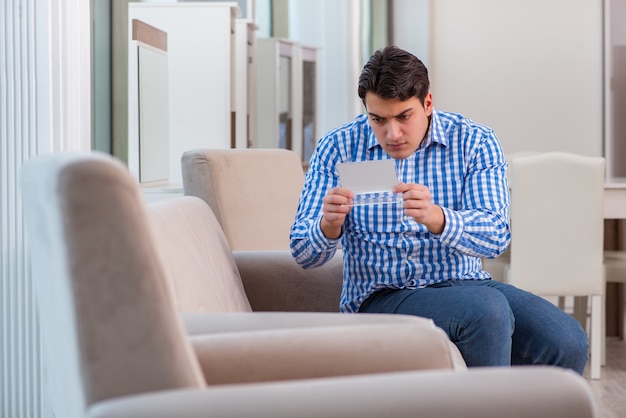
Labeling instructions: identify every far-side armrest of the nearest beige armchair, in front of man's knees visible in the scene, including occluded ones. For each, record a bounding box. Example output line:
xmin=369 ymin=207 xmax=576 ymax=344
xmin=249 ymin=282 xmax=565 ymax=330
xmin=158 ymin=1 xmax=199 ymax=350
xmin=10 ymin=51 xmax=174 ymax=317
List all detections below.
xmin=185 ymin=323 xmax=454 ymax=385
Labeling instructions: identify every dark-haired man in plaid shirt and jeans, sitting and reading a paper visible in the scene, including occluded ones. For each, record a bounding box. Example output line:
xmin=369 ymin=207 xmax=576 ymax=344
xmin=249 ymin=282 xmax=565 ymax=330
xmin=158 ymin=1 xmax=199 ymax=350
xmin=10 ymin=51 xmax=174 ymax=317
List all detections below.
xmin=291 ymin=46 xmax=588 ymax=374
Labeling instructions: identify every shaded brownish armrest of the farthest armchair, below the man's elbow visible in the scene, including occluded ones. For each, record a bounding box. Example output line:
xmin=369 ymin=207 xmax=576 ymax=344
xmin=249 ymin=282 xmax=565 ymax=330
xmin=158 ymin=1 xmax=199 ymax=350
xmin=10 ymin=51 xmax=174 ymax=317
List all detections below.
xmin=233 ymin=250 xmax=343 ymax=312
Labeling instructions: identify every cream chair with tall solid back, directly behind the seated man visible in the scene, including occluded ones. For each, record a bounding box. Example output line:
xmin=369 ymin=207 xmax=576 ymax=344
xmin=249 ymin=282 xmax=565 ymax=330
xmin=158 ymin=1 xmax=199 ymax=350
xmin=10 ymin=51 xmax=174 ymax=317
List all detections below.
xmin=504 ymin=152 xmax=605 ymax=379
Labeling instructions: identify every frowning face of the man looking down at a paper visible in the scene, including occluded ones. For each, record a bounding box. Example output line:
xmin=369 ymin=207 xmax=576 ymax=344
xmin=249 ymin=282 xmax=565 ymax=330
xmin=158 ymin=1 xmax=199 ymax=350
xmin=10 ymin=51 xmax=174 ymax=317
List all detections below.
xmin=365 ymin=92 xmax=433 ymax=160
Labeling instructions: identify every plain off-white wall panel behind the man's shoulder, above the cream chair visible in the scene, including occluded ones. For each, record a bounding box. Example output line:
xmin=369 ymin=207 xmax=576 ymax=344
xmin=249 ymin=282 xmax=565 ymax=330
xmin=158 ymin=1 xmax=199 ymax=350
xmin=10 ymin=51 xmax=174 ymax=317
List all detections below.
xmin=429 ymin=0 xmax=603 ymax=156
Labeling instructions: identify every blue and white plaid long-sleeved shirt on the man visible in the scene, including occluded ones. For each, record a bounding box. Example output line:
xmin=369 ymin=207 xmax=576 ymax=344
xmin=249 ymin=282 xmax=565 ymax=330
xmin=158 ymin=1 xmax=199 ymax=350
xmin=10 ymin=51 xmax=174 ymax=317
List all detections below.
xmin=291 ymin=111 xmax=510 ymax=312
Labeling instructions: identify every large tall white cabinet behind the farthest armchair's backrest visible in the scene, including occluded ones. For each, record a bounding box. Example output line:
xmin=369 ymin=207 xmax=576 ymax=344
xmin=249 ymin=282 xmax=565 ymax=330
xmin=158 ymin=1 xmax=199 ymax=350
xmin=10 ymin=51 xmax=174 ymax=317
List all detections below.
xmin=128 ymin=2 xmax=240 ymax=184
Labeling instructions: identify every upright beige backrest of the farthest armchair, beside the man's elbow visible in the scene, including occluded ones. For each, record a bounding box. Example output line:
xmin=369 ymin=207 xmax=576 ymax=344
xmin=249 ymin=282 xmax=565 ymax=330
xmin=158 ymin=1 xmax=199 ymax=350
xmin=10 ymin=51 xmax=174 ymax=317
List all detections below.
xmin=181 ymin=149 xmax=304 ymax=251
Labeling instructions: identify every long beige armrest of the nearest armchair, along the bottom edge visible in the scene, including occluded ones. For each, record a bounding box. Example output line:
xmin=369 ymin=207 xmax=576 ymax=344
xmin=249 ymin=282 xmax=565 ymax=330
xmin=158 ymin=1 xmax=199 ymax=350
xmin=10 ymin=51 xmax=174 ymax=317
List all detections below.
xmin=86 ymin=366 xmax=595 ymax=418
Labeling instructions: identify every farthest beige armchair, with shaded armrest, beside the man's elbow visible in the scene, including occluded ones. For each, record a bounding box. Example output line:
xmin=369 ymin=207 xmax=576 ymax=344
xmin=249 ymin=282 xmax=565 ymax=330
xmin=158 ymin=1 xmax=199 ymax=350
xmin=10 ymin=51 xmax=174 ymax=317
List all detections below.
xmin=181 ymin=149 xmax=343 ymax=312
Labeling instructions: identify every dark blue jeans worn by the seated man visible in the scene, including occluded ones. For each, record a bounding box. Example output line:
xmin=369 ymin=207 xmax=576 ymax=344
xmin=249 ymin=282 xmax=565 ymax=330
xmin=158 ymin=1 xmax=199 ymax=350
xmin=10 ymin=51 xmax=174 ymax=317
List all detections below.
xmin=359 ymin=280 xmax=589 ymax=374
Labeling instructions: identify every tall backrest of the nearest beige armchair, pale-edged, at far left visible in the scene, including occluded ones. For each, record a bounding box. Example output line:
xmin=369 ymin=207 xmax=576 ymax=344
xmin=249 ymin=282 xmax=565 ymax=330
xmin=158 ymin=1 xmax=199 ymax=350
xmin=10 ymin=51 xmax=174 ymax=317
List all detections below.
xmin=22 ymin=153 xmax=204 ymax=418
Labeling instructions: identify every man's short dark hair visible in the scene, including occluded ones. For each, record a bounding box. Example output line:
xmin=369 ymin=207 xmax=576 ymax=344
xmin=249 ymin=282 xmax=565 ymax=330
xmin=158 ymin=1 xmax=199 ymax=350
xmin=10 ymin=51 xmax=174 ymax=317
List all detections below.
xmin=358 ymin=46 xmax=430 ymax=105
